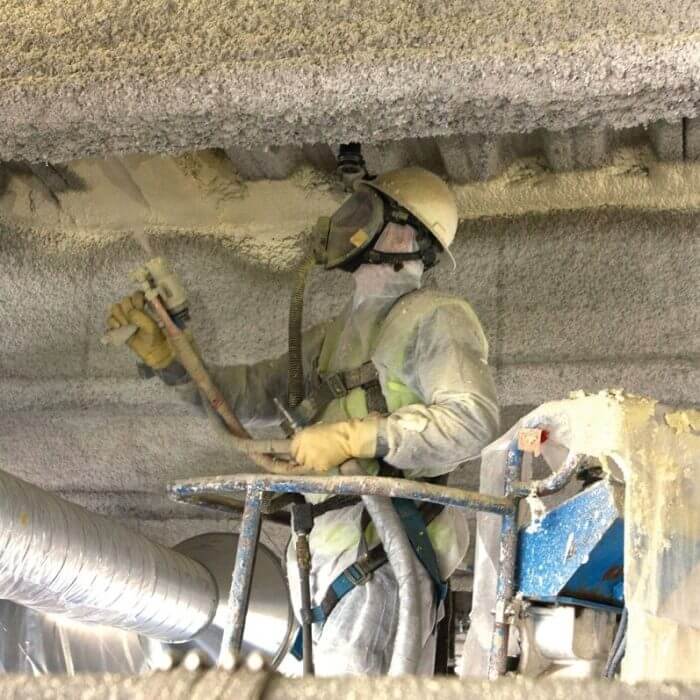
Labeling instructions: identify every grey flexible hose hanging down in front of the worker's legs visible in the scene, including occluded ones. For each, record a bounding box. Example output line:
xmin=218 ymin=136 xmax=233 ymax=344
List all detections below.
xmin=362 ymin=496 xmax=424 ymax=676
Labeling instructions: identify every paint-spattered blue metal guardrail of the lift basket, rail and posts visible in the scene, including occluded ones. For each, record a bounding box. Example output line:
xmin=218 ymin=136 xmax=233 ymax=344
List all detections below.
xmin=169 ymin=427 xmax=580 ymax=679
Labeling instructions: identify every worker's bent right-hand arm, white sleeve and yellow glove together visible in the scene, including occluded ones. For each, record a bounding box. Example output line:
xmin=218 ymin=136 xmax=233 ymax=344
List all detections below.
xmin=291 ymin=304 xmax=499 ymax=478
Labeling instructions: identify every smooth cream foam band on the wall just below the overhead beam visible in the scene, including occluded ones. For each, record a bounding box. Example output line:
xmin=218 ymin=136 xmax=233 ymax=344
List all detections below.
xmin=0 ymin=142 xmax=700 ymax=258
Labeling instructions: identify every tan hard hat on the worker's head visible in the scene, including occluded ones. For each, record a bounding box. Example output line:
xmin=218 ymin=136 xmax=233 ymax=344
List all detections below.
xmin=362 ymin=167 xmax=459 ymax=263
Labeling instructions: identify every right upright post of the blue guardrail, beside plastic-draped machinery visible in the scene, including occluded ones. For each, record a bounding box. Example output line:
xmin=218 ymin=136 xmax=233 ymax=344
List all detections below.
xmin=488 ymin=439 xmax=523 ymax=680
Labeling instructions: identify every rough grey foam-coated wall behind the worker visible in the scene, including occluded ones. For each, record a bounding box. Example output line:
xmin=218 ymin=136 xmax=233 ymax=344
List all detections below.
xmin=0 ymin=210 xmax=700 ymax=540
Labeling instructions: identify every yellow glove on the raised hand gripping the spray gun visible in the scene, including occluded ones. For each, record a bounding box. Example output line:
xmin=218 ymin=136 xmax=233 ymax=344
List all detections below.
xmin=107 ymin=292 xmax=175 ymax=369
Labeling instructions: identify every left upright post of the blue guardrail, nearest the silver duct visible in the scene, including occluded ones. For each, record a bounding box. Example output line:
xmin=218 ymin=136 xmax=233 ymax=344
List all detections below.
xmin=219 ymin=486 xmax=263 ymax=666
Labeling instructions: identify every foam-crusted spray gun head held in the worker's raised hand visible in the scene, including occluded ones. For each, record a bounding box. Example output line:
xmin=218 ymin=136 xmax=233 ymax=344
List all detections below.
xmin=101 ymin=257 xmax=190 ymax=346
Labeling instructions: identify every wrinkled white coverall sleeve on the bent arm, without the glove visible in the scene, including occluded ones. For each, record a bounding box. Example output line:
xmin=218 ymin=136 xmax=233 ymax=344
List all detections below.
xmin=380 ymin=304 xmax=499 ymax=478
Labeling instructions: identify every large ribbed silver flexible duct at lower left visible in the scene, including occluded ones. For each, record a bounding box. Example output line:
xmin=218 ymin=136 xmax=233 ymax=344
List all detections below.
xmin=0 ymin=472 xmax=218 ymax=641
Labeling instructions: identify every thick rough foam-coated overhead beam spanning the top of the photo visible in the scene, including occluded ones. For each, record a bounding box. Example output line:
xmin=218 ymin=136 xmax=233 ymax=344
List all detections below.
xmin=0 ymin=0 xmax=700 ymax=161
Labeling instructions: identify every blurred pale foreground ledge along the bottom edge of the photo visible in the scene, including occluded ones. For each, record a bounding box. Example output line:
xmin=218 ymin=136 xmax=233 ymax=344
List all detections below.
xmin=0 ymin=667 xmax=698 ymax=700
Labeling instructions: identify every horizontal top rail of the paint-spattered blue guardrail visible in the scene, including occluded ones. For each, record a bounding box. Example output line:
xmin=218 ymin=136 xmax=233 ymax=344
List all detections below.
xmin=169 ymin=474 xmax=515 ymax=515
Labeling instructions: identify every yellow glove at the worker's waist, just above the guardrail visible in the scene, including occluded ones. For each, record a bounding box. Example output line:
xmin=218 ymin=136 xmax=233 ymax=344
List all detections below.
xmin=291 ymin=418 xmax=379 ymax=472
